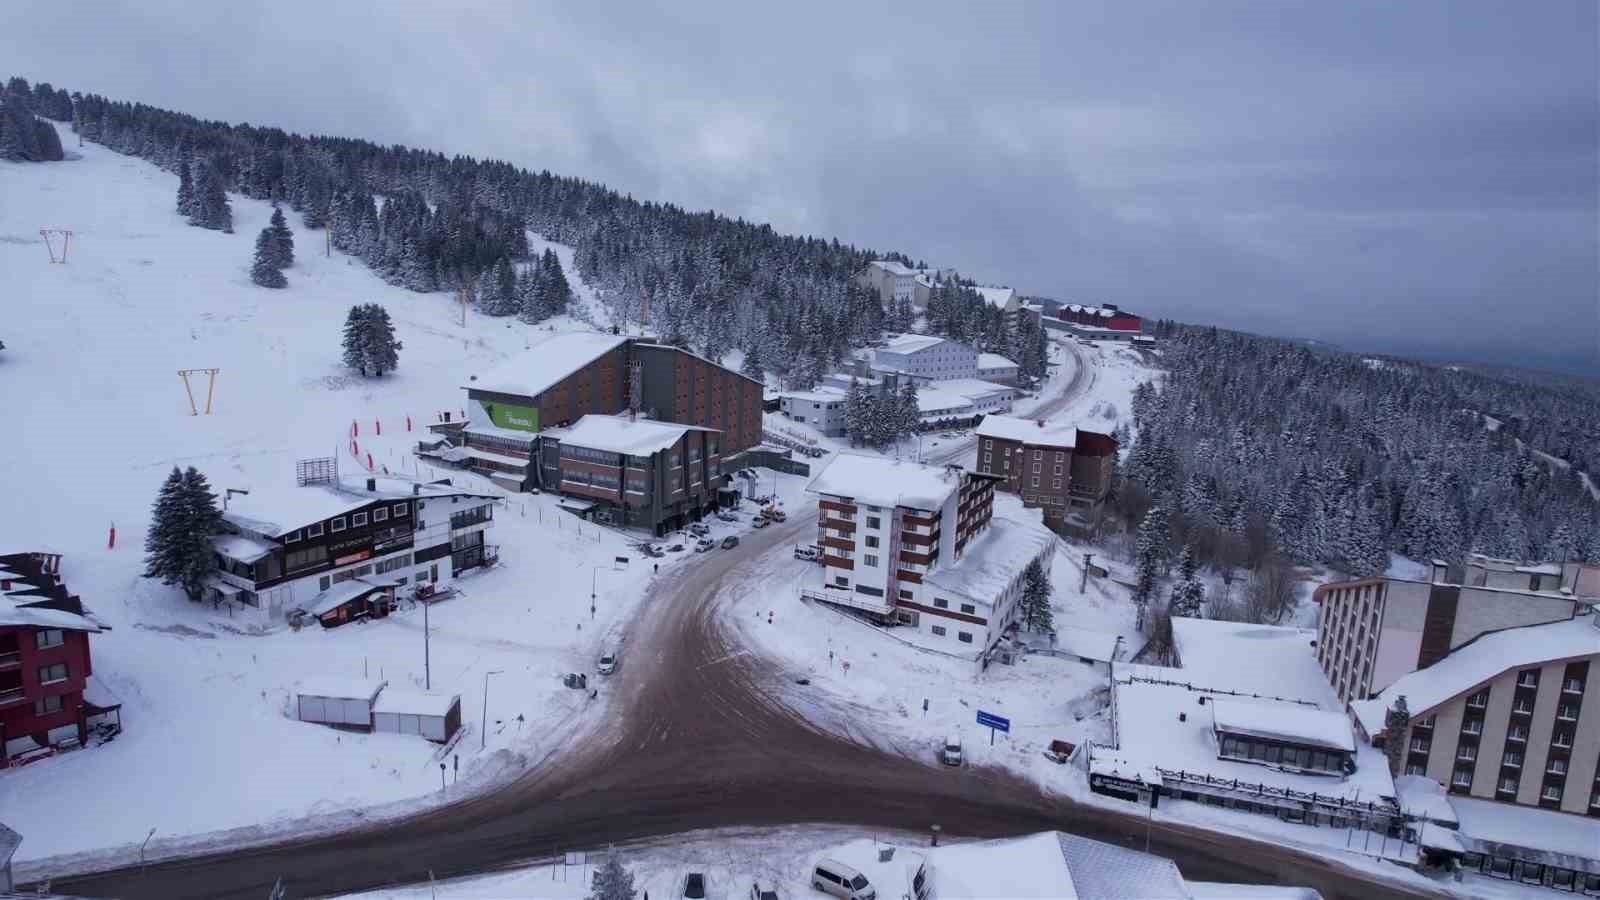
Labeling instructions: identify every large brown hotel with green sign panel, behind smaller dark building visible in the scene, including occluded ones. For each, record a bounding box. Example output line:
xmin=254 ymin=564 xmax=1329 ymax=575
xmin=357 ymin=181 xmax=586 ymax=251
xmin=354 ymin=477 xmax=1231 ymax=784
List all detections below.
xmin=456 ymin=331 xmax=763 ymax=490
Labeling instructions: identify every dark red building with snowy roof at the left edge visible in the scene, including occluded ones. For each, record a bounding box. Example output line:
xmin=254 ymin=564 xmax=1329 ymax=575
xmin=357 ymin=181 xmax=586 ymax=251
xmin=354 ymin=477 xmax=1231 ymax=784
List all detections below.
xmin=0 ymin=552 xmax=115 ymax=769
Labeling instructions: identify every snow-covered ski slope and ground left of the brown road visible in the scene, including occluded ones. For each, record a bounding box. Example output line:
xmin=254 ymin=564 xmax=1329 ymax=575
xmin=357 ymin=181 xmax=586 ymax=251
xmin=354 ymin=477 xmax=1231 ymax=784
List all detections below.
xmin=0 ymin=129 xmax=761 ymax=873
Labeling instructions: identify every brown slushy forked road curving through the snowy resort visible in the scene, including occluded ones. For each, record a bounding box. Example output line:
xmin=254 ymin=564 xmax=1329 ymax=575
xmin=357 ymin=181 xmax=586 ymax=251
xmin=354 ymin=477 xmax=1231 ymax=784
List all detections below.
xmin=43 ymin=341 xmax=1440 ymax=900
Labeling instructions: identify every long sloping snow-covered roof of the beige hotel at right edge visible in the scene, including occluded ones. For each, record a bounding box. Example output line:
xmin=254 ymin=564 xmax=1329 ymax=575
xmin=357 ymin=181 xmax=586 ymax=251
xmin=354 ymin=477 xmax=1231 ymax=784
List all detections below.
xmin=1350 ymin=615 xmax=1600 ymax=735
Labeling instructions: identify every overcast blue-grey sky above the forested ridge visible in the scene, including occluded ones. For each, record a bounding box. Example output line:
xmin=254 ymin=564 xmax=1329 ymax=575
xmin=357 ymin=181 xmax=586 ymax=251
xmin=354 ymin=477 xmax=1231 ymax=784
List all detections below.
xmin=0 ymin=0 xmax=1600 ymax=372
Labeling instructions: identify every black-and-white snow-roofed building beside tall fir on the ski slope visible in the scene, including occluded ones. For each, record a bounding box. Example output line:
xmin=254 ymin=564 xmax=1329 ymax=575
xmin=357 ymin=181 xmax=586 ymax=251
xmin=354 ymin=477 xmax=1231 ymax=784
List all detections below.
xmin=208 ymin=476 xmax=498 ymax=618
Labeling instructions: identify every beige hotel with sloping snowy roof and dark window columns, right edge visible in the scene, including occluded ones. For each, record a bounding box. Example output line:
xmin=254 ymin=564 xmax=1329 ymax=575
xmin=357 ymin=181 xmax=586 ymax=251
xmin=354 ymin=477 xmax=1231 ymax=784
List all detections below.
xmin=1350 ymin=613 xmax=1600 ymax=816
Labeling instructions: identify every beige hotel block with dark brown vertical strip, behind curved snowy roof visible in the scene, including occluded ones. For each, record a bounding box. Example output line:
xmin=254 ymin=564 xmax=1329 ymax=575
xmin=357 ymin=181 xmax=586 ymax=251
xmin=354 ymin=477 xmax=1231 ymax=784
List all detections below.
xmin=1312 ymin=557 xmax=1592 ymax=703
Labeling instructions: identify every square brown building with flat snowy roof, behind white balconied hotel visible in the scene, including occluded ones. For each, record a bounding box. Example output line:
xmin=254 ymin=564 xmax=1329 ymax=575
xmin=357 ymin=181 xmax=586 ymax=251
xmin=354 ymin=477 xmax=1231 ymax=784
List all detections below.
xmin=976 ymin=415 xmax=1117 ymax=530
